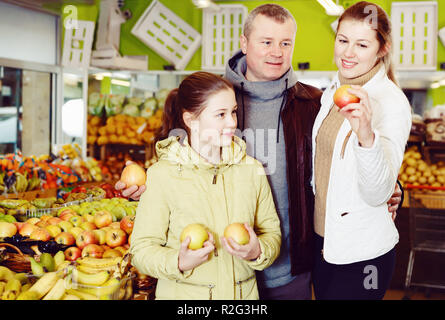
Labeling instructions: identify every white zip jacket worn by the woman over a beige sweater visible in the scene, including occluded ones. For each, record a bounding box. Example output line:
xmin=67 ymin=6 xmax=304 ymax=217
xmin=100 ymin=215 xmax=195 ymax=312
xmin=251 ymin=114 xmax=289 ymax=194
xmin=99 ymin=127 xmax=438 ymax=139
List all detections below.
xmin=312 ymin=66 xmax=411 ymax=264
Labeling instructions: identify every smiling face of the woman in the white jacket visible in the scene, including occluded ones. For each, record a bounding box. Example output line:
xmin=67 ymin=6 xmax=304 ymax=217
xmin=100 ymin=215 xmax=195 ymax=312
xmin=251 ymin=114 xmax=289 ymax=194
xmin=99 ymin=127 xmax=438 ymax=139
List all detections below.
xmin=334 ymin=19 xmax=383 ymax=79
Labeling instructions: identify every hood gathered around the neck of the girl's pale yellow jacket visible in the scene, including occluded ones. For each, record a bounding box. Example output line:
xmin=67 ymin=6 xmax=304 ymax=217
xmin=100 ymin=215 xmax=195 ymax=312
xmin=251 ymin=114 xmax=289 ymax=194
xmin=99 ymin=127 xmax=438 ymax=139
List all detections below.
xmin=156 ymin=136 xmax=246 ymax=168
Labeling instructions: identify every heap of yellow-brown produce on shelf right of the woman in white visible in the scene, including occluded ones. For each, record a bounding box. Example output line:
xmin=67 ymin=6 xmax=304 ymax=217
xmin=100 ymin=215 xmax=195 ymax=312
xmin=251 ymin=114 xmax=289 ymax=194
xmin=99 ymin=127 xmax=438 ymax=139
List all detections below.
xmin=398 ymin=146 xmax=445 ymax=187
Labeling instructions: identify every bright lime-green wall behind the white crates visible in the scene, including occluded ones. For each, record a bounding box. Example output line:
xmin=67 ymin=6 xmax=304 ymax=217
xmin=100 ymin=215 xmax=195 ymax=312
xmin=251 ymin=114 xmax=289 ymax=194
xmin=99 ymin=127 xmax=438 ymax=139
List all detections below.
xmin=62 ymin=0 xmax=445 ymax=71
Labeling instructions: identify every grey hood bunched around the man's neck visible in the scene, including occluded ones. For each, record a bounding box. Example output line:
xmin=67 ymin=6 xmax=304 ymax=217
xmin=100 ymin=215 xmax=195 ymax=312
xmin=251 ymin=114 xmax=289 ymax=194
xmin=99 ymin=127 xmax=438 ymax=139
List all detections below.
xmin=225 ymin=50 xmax=298 ymax=100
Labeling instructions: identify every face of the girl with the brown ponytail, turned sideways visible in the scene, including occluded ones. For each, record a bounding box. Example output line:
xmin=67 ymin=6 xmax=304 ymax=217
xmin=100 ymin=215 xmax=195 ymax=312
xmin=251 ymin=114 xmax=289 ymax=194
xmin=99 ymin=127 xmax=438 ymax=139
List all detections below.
xmin=186 ymin=89 xmax=237 ymax=151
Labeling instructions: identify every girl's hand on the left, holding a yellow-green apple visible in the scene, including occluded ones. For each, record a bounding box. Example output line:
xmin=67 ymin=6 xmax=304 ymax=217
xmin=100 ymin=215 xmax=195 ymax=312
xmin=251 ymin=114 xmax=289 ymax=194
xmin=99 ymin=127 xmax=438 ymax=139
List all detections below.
xmin=178 ymin=231 xmax=215 ymax=272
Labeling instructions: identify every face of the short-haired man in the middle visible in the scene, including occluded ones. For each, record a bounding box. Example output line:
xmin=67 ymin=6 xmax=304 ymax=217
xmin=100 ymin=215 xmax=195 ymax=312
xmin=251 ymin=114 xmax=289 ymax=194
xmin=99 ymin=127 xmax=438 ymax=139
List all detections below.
xmin=240 ymin=14 xmax=296 ymax=81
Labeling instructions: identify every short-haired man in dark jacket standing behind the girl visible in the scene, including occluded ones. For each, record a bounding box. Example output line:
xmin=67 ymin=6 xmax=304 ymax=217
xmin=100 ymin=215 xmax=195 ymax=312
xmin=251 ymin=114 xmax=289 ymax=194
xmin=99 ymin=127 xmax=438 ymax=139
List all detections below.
xmin=116 ymin=4 xmax=401 ymax=300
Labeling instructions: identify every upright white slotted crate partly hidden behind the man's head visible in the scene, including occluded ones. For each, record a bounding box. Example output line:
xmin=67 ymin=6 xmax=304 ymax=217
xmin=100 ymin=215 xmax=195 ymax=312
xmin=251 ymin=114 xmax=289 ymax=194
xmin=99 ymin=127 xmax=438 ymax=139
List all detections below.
xmin=201 ymin=5 xmax=248 ymax=71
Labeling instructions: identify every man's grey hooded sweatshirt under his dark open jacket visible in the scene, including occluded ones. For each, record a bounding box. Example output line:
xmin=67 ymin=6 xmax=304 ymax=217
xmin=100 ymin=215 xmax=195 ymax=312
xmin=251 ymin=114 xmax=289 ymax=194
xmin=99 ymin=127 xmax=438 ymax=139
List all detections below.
xmin=225 ymin=51 xmax=297 ymax=288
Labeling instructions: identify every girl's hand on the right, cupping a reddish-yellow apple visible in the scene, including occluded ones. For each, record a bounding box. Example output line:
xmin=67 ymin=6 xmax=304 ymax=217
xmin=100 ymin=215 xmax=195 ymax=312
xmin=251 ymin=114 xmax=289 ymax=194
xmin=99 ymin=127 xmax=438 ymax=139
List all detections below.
xmin=221 ymin=222 xmax=261 ymax=260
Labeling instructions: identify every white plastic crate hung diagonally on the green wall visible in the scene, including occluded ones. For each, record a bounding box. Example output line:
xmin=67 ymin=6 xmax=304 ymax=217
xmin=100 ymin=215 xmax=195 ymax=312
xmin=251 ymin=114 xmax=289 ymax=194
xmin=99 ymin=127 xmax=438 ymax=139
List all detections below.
xmin=131 ymin=0 xmax=201 ymax=70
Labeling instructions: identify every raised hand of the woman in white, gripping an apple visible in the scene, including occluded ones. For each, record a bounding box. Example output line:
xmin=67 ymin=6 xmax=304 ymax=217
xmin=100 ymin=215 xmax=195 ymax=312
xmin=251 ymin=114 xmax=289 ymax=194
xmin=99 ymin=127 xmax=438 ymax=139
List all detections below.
xmin=339 ymin=86 xmax=375 ymax=148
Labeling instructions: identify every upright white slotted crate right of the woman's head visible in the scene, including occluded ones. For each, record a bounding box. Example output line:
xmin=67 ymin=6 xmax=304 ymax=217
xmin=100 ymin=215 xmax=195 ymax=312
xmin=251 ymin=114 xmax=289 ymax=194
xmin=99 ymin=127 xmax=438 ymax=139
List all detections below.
xmin=391 ymin=1 xmax=438 ymax=70
